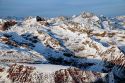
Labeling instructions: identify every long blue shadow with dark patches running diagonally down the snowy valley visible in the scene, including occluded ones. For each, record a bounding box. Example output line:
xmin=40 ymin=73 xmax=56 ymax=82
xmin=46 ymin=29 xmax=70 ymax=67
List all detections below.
xmin=5 ymin=32 xmax=125 ymax=83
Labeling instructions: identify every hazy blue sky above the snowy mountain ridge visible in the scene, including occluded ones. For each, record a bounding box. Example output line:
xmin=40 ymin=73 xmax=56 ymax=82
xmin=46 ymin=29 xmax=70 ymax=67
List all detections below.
xmin=0 ymin=0 xmax=125 ymax=17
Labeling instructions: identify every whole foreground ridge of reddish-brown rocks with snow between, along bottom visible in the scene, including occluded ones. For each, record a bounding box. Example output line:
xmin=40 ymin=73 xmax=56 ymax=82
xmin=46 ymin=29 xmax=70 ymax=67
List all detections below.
xmin=0 ymin=64 xmax=108 ymax=83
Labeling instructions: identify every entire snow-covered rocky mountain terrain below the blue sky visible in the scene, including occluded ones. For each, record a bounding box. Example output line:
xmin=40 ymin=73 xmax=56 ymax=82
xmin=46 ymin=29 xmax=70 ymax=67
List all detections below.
xmin=0 ymin=12 xmax=125 ymax=83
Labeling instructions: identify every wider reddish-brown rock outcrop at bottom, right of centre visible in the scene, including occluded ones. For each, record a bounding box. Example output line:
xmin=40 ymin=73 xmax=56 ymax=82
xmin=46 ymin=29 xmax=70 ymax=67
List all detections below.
xmin=55 ymin=68 xmax=103 ymax=83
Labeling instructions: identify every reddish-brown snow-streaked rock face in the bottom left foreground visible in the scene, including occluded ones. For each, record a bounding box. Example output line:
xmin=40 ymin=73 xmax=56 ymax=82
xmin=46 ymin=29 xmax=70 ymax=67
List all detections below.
xmin=7 ymin=64 xmax=35 ymax=83
